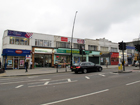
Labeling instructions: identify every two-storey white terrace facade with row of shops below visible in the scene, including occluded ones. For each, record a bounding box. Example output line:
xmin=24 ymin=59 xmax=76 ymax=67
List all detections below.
xmin=2 ymin=30 xmax=118 ymax=69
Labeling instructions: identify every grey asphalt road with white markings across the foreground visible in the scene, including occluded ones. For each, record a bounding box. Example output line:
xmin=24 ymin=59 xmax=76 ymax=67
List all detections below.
xmin=0 ymin=67 xmax=140 ymax=105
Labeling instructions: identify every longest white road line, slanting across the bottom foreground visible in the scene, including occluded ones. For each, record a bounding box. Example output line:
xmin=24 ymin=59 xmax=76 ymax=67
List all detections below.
xmin=41 ymin=89 xmax=109 ymax=105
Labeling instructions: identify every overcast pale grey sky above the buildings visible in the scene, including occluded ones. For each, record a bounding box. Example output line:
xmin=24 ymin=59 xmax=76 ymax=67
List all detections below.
xmin=0 ymin=0 xmax=140 ymax=52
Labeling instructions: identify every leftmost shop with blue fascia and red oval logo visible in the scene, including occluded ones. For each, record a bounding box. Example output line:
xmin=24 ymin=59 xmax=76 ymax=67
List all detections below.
xmin=2 ymin=49 xmax=31 ymax=69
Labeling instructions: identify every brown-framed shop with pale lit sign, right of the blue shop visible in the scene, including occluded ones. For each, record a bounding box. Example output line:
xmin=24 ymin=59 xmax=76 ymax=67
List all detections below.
xmin=32 ymin=47 xmax=54 ymax=68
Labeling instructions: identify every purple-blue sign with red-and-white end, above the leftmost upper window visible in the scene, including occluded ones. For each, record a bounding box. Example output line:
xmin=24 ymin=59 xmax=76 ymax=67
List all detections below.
xmin=8 ymin=30 xmax=33 ymax=38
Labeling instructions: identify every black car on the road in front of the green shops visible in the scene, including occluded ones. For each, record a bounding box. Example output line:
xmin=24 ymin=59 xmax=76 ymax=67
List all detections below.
xmin=71 ymin=62 xmax=103 ymax=73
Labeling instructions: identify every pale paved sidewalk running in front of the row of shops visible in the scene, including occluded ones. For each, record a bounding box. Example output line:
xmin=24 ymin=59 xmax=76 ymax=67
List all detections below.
xmin=0 ymin=65 xmax=118 ymax=77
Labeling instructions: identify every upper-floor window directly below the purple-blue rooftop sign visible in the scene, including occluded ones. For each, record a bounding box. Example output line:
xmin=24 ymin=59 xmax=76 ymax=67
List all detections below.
xmin=10 ymin=37 xmax=29 ymax=45
